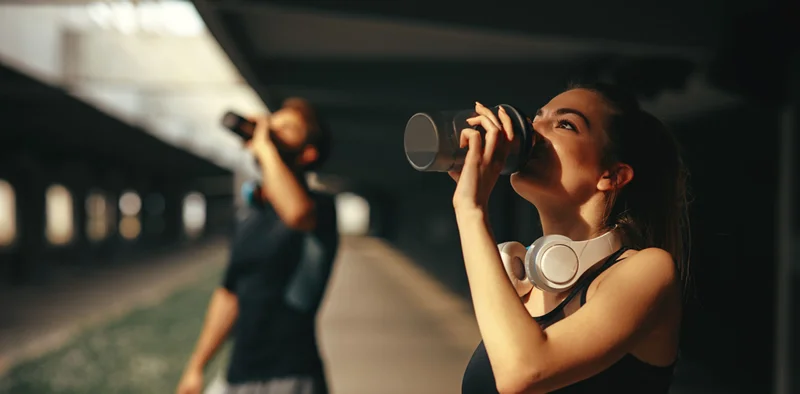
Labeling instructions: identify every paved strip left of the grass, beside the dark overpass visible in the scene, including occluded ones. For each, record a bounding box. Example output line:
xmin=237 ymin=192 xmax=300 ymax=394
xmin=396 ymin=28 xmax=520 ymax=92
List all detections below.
xmin=0 ymin=238 xmax=227 ymax=378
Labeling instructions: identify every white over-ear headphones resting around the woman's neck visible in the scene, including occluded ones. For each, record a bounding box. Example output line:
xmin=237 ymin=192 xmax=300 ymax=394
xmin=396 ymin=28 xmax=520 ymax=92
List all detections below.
xmin=497 ymin=230 xmax=621 ymax=297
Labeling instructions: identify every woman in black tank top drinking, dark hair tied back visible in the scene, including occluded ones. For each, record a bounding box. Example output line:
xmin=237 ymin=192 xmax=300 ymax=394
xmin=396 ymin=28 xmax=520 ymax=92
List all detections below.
xmin=450 ymin=81 xmax=688 ymax=394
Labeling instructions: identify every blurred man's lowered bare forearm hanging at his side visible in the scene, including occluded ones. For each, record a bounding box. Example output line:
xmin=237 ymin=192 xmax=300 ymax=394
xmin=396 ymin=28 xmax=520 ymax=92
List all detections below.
xmin=177 ymin=288 xmax=234 ymax=375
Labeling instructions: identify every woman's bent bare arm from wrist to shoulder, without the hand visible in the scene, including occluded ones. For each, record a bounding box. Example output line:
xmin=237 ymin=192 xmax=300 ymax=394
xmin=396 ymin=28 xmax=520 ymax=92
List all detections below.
xmin=456 ymin=209 xmax=675 ymax=393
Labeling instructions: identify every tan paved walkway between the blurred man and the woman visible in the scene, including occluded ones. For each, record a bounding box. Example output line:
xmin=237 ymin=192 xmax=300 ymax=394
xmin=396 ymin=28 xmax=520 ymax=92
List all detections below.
xmin=206 ymin=238 xmax=480 ymax=394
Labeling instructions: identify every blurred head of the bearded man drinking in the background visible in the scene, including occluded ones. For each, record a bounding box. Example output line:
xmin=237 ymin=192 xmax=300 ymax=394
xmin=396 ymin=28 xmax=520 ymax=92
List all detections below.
xmin=269 ymin=97 xmax=330 ymax=171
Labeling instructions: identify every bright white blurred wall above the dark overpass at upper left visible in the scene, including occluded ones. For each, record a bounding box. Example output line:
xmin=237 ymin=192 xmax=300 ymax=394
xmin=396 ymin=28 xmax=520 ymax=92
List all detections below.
xmin=0 ymin=1 xmax=267 ymax=172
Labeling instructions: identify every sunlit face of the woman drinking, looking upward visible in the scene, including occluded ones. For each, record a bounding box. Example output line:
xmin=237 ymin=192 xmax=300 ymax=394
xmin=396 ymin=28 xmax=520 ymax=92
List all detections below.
xmin=511 ymin=89 xmax=608 ymax=206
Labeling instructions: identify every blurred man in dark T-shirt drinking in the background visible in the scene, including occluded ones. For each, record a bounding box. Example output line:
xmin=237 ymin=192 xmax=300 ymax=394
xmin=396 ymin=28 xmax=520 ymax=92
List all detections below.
xmin=177 ymin=98 xmax=339 ymax=394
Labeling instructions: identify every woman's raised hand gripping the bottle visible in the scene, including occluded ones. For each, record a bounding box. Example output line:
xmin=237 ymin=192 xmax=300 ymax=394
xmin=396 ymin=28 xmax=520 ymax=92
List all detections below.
xmin=449 ymin=102 xmax=515 ymax=211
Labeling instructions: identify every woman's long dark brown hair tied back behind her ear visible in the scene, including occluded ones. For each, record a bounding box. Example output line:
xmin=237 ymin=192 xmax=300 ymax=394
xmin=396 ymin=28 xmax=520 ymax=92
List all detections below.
xmin=569 ymin=83 xmax=691 ymax=295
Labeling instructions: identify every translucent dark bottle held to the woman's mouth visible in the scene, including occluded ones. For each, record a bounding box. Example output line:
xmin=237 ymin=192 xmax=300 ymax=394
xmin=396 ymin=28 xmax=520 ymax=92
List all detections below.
xmin=404 ymin=104 xmax=535 ymax=175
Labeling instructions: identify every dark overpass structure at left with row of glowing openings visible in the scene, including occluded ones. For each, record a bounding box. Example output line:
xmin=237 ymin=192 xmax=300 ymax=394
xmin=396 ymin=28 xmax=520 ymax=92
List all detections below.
xmin=0 ymin=65 xmax=233 ymax=286
